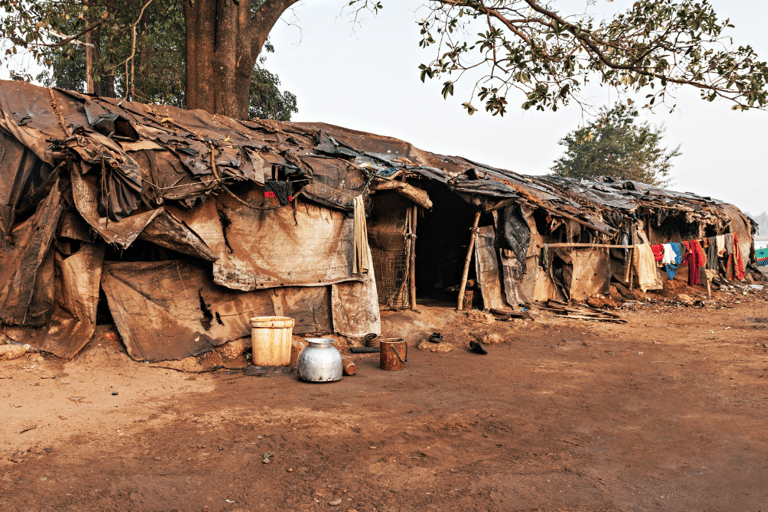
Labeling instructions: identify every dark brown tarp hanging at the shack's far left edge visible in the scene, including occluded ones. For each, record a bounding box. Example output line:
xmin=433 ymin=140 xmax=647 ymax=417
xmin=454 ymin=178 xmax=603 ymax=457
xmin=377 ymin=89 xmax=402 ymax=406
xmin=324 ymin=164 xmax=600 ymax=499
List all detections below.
xmin=0 ymin=180 xmax=64 ymax=325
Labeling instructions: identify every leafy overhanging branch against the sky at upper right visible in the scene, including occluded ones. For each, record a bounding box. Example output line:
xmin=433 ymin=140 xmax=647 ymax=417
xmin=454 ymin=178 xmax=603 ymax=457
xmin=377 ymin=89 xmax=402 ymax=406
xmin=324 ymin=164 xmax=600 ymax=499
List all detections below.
xmin=414 ymin=0 xmax=768 ymax=115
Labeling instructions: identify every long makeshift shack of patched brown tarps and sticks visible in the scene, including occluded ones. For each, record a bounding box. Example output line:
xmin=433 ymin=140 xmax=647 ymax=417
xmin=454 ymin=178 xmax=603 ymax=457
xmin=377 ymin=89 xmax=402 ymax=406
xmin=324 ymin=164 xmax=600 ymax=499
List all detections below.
xmin=0 ymin=82 xmax=753 ymax=361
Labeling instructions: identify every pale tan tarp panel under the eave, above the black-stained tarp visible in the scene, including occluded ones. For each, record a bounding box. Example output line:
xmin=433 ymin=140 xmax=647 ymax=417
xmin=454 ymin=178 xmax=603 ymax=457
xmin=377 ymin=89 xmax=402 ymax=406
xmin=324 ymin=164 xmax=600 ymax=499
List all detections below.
xmin=174 ymin=196 xmax=360 ymax=291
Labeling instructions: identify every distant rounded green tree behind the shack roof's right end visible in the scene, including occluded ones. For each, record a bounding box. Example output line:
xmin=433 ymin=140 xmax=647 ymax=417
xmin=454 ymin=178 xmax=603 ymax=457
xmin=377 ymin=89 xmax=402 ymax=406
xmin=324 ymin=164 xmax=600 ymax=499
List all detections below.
xmin=552 ymin=104 xmax=681 ymax=187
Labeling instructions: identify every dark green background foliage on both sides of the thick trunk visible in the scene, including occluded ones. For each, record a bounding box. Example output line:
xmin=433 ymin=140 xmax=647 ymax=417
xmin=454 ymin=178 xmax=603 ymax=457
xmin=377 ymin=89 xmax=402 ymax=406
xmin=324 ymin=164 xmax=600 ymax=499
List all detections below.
xmin=9 ymin=0 xmax=298 ymax=121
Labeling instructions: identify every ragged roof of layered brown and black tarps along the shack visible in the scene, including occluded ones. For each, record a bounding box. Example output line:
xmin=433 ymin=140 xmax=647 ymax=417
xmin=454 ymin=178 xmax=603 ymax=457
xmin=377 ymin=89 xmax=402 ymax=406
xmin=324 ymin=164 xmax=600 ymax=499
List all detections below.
xmin=0 ymin=82 xmax=748 ymax=248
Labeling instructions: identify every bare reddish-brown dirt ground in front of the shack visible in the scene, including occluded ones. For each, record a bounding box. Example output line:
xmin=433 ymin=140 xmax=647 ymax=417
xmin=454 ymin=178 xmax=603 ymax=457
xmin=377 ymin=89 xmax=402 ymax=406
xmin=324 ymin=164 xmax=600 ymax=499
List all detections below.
xmin=0 ymin=289 xmax=768 ymax=512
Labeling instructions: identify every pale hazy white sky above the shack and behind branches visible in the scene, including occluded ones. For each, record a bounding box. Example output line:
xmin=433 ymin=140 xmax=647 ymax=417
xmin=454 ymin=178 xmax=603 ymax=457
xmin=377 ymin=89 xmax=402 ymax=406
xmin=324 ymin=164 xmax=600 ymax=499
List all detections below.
xmin=266 ymin=0 xmax=768 ymax=214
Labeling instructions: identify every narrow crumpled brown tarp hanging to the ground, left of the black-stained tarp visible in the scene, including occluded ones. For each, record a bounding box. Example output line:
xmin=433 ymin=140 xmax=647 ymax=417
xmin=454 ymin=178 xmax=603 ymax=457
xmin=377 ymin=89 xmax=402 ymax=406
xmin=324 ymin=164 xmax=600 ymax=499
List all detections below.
xmin=38 ymin=244 xmax=104 ymax=359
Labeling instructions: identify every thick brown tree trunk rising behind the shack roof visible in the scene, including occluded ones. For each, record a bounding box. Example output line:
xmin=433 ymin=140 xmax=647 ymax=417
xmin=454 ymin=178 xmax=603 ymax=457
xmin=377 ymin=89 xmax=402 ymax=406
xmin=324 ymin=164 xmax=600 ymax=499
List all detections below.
xmin=184 ymin=0 xmax=298 ymax=119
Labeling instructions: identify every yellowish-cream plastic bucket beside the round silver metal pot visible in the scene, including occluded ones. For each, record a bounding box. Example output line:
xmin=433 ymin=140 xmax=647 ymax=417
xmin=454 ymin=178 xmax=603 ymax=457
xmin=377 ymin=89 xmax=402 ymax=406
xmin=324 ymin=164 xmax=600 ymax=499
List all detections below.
xmin=251 ymin=316 xmax=294 ymax=366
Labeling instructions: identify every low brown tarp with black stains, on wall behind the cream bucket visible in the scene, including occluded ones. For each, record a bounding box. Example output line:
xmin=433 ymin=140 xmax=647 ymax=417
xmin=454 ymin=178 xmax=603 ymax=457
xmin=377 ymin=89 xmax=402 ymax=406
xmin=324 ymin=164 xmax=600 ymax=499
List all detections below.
xmin=102 ymin=261 xmax=332 ymax=361
